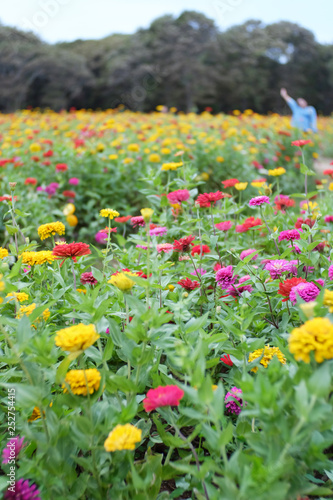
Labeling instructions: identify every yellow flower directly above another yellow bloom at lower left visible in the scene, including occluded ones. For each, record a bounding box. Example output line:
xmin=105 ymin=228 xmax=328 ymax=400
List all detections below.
xmin=55 ymin=323 xmax=99 ymax=352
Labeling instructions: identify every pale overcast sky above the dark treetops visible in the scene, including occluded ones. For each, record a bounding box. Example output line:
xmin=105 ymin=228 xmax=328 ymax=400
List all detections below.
xmin=0 ymin=0 xmax=333 ymax=43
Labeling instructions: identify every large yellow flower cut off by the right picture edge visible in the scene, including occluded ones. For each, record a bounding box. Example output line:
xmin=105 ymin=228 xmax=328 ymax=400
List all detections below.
xmin=289 ymin=318 xmax=333 ymax=363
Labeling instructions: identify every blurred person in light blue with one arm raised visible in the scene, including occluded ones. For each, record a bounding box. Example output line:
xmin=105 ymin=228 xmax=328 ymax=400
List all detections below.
xmin=280 ymin=88 xmax=318 ymax=132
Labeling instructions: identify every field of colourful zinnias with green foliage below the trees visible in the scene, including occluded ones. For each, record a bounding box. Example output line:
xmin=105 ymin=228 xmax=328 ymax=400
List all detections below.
xmin=0 ymin=107 xmax=333 ymax=500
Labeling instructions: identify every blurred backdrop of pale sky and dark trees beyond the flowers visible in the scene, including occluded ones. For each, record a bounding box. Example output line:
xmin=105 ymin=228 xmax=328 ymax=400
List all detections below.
xmin=0 ymin=0 xmax=333 ymax=115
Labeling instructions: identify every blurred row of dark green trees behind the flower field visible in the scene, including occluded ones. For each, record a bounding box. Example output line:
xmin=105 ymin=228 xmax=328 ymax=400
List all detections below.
xmin=0 ymin=11 xmax=333 ymax=115
